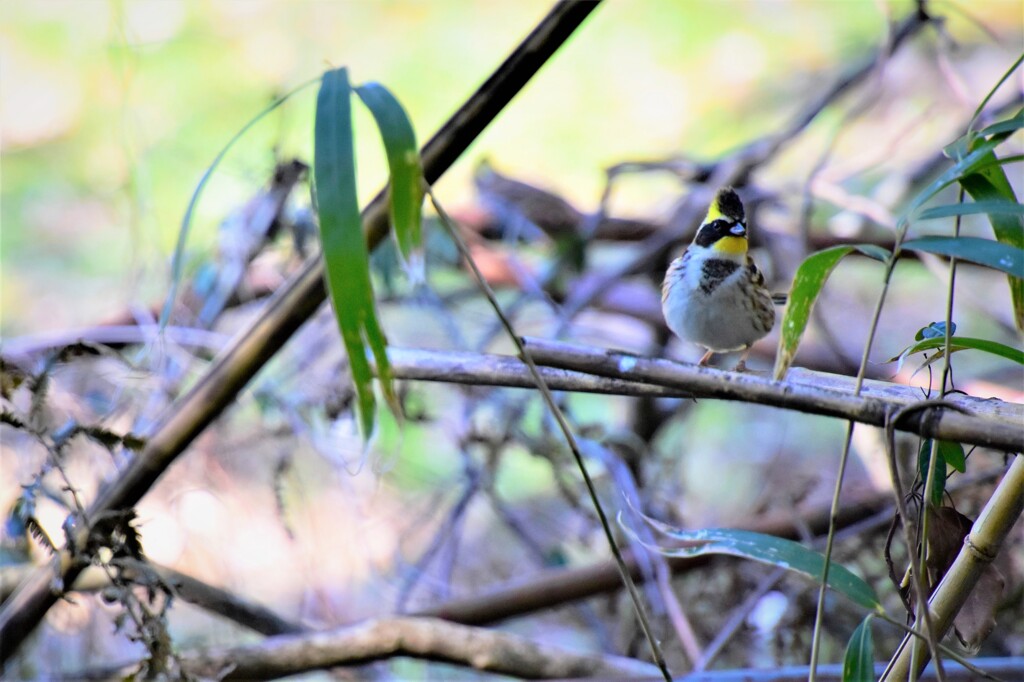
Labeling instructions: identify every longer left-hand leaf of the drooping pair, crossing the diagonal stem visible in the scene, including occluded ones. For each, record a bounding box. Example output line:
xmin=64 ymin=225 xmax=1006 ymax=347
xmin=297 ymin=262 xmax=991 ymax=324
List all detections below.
xmin=313 ymin=69 xmax=393 ymax=438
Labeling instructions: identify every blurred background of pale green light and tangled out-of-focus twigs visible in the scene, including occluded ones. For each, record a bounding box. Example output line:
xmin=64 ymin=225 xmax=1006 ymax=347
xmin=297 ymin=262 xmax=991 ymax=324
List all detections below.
xmin=0 ymin=0 xmax=1024 ymax=679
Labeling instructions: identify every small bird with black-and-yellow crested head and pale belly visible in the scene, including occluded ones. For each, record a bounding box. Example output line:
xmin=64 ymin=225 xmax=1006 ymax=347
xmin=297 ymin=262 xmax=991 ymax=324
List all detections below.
xmin=662 ymin=187 xmax=775 ymax=372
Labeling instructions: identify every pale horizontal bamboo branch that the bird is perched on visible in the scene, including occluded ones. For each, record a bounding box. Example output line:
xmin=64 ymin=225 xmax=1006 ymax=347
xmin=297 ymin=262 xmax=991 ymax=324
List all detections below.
xmin=380 ymin=339 xmax=1024 ymax=453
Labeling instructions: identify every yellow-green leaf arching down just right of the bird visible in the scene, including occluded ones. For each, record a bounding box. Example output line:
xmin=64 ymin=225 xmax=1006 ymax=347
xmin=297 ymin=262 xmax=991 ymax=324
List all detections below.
xmin=774 ymin=244 xmax=891 ymax=381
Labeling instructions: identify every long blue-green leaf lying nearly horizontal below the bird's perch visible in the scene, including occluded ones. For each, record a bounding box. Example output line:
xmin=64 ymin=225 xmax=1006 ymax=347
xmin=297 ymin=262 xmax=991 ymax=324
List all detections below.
xmin=626 ymin=516 xmax=882 ymax=610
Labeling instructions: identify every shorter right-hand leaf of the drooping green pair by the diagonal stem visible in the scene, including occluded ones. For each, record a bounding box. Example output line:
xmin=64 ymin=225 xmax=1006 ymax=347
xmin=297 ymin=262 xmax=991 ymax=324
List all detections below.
xmin=355 ymin=83 xmax=424 ymax=281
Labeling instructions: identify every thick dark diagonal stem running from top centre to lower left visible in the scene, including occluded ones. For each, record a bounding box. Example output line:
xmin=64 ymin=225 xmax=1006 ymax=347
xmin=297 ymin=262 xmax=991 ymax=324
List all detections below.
xmin=0 ymin=0 xmax=598 ymax=662
